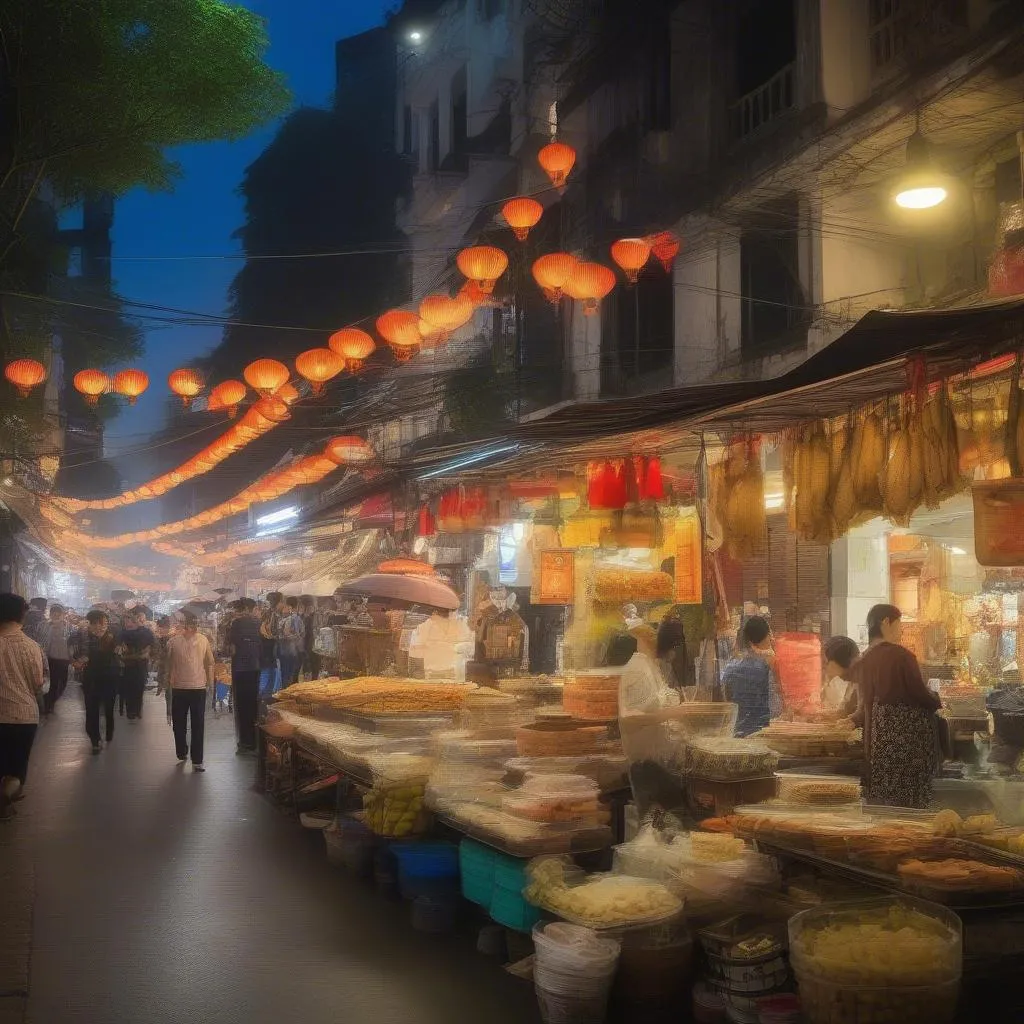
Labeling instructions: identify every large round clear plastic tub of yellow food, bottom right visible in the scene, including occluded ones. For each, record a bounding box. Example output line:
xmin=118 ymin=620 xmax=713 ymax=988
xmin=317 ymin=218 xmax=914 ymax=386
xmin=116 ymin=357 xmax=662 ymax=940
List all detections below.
xmin=788 ymin=897 xmax=963 ymax=1024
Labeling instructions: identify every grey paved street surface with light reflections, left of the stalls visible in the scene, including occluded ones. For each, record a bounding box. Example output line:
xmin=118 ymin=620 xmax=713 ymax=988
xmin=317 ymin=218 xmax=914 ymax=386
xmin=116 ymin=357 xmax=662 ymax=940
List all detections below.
xmin=0 ymin=685 xmax=537 ymax=1024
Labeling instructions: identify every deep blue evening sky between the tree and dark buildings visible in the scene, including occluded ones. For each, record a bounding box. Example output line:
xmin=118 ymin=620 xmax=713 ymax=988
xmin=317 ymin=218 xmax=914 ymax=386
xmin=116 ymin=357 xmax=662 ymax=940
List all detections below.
xmin=106 ymin=0 xmax=396 ymax=458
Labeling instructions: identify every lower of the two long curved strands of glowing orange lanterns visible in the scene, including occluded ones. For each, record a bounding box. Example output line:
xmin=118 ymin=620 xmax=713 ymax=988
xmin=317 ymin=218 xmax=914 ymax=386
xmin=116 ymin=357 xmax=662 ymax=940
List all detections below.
xmin=56 ymin=436 xmax=373 ymax=550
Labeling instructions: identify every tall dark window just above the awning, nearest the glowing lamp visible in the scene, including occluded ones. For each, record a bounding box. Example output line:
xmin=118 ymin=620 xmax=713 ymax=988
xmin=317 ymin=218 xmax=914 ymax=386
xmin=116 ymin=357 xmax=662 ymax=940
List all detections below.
xmin=739 ymin=195 xmax=809 ymax=354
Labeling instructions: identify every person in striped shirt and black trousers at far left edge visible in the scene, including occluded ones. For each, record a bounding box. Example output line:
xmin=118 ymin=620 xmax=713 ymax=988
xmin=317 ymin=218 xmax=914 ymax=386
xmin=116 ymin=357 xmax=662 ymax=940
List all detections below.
xmin=0 ymin=594 xmax=43 ymax=818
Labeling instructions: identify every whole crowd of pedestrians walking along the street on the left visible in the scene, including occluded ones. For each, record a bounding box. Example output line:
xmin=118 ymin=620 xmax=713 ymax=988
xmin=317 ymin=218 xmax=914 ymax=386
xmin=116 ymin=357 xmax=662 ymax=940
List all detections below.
xmin=0 ymin=593 xmax=366 ymax=817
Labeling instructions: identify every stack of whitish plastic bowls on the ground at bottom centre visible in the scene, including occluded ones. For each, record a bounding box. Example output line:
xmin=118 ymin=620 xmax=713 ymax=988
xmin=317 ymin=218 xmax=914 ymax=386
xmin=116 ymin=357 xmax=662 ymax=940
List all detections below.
xmin=534 ymin=922 xmax=620 ymax=1024
